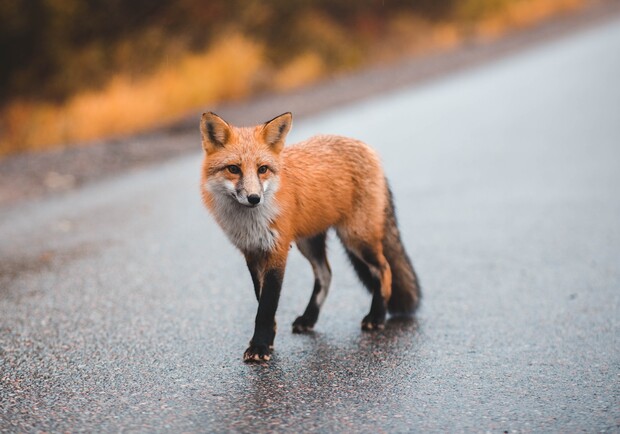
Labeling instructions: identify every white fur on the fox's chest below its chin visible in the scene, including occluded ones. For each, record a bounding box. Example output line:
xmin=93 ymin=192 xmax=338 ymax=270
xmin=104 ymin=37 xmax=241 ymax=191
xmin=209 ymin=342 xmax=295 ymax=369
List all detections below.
xmin=211 ymin=181 xmax=278 ymax=252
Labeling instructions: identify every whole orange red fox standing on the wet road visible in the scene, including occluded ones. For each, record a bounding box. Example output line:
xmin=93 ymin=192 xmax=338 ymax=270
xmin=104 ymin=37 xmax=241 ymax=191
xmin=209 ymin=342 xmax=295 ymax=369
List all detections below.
xmin=200 ymin=112 xmax=421 ymax=363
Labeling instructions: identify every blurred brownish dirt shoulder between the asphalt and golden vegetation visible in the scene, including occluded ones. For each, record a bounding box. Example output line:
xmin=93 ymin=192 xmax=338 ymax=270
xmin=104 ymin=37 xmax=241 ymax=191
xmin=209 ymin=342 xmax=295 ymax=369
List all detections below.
xmin=0 ymin=0 xmax=620 ymax=210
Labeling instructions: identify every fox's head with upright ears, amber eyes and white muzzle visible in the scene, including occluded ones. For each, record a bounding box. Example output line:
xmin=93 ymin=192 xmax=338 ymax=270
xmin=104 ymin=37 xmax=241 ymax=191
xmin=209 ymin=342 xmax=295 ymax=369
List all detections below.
xmin=200 ymin=112 xmax=293 ymax=208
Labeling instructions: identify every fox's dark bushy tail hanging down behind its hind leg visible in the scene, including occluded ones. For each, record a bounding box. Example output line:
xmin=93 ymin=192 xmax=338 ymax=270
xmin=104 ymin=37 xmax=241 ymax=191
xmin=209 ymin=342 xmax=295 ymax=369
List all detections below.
xmin=383 ymin=187 xmax=421 ymax=315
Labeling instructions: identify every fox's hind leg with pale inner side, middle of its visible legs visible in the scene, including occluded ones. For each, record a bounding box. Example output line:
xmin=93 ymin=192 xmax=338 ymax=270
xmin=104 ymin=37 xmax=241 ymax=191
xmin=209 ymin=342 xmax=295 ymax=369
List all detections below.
xmin=293 ymin=232 xmax=332 ymax=333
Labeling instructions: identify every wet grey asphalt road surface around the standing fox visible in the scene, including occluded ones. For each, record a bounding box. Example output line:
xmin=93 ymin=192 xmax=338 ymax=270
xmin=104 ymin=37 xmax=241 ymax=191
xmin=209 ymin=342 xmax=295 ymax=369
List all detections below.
xmin=0 ymin=15 xmax=620 ymax=432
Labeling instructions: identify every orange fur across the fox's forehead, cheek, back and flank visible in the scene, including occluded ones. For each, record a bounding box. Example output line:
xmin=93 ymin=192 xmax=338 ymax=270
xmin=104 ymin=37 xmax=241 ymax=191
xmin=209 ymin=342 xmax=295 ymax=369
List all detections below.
xmin=201 ymin=116 xmax=387 ymax=272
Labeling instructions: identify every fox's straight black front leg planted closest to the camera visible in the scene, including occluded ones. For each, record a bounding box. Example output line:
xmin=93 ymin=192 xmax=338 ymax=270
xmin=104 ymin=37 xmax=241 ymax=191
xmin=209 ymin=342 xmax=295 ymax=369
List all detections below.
xmin=243 ymin=268 xmax=284 ymax=362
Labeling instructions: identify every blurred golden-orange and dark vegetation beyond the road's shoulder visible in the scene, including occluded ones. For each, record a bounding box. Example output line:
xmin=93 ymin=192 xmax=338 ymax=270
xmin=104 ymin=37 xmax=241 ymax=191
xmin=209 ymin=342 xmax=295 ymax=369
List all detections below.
xmin=0 ymin=0 xmax=592 ymax=159
